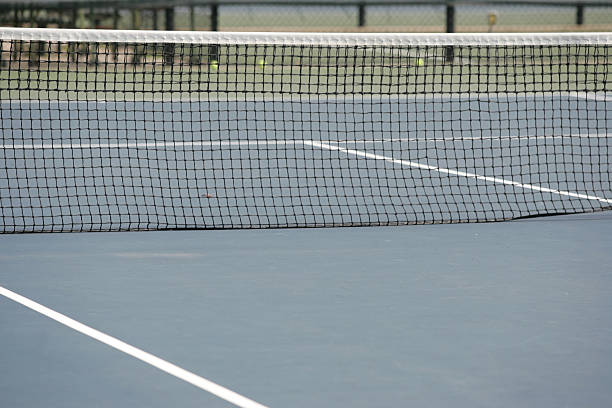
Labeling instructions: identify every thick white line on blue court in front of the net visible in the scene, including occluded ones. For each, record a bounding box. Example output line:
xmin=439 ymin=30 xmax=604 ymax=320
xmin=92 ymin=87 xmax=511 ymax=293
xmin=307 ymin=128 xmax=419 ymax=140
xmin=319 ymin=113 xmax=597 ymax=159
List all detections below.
xmin=0 ymin=286 xmax=267 ymax=408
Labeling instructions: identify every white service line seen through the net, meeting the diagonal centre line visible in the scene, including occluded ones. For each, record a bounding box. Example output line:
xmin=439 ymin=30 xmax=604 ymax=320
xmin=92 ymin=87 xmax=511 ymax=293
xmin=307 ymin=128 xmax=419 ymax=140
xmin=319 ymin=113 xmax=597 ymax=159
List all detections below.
xmin=0 ymin=133 xmax=612 ymax=150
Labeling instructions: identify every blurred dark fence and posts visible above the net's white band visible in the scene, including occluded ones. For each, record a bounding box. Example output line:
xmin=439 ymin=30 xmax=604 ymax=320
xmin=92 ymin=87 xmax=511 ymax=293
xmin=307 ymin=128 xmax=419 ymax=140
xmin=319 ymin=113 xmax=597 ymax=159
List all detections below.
xmin=0 ymin=0 xmax=612 ymax=33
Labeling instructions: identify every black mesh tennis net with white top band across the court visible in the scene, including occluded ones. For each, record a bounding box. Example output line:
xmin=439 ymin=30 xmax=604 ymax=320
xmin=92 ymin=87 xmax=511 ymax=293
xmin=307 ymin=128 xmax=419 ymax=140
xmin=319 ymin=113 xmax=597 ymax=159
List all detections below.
xmin=0 ymin=28 xmax=612 ymax=233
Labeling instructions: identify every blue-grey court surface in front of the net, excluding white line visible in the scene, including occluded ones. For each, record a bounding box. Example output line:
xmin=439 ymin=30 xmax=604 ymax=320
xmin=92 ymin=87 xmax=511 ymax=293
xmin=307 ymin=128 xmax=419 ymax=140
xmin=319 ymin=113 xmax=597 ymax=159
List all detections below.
xmin=0 ymin=213 xmax=612 ymax=408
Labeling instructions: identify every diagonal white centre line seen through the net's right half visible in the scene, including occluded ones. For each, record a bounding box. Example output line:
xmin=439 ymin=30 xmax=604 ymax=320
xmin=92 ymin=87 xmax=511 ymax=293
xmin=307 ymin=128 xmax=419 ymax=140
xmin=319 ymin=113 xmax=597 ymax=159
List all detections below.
xmin=304 ymin=141 xmax=612 ymax=204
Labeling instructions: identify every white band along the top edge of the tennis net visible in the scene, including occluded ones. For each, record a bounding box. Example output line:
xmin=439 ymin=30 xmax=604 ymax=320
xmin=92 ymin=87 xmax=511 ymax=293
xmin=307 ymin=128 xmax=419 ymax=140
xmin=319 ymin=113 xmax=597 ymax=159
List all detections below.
xmin=0 ymin=27 xmax=612 ymax=47
